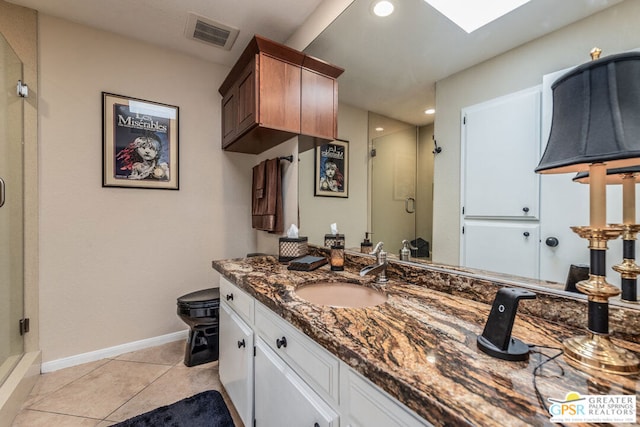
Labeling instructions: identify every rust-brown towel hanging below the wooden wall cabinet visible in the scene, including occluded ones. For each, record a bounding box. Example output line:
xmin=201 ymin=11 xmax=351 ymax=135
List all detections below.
xmin=251 ymin=158 xmax=284 ymax=233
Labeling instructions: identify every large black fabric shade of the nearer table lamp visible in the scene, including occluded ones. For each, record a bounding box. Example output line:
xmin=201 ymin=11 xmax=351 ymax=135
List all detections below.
xmin=535 ymin=52 xmax=640 ymax=173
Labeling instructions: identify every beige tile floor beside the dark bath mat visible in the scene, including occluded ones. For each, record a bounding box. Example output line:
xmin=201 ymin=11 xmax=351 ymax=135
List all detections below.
xmin=12 ymin=341 xmax=243 ymax=427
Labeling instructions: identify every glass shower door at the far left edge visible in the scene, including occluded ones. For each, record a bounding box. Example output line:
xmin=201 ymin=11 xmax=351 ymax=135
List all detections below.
xmin=0 ymin=34 xmax=24 ymax=384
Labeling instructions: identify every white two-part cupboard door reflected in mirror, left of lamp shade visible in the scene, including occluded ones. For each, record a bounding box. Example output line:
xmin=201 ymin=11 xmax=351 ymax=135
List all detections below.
xmin=460 ymin=87 xmax=540 ymax=278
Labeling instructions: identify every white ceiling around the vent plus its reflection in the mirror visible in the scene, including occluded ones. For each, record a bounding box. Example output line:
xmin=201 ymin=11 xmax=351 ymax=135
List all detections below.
xmin=7 ymin=0 xmax=624 ymax=124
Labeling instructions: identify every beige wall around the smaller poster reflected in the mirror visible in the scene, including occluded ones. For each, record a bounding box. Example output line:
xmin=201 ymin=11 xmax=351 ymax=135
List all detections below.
xmin=298 ymin=104 xmax=369 ymax=248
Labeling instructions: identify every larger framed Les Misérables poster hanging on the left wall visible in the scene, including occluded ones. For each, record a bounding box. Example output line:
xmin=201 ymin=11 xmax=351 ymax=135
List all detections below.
xmin=102 ymin=92 xmax=179 ymax=190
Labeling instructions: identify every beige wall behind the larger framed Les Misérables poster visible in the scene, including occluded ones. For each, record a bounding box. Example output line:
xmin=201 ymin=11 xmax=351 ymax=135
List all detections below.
xmin=38 ymin=15 xmax=256 ymax=362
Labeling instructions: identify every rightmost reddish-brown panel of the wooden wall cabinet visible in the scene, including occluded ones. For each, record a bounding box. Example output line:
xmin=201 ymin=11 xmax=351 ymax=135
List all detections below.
xmin=300 ymin=68 xmax=338 ymax=139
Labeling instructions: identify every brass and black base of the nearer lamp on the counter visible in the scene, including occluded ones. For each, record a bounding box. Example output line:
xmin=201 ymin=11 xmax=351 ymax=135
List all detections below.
xmin=563 ymin=226 xmax=640 ymax=374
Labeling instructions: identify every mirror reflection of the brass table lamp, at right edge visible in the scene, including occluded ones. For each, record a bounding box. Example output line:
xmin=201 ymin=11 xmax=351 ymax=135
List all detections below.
xmin=573 ymin=166 xmax=640 ymax=302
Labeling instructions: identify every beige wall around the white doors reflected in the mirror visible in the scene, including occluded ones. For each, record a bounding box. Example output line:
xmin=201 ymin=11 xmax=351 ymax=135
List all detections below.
xmin=433 ymin=0 xmax=640 ymax=264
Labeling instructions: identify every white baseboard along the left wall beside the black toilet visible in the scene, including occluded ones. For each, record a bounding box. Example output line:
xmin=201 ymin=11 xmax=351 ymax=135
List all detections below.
xmin=40 ymin=329 xmax=189 ymax=374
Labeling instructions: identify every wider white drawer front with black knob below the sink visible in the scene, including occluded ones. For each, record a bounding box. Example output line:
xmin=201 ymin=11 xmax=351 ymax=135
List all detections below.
xmin=255 ymin=303 xmax=339 ymax=403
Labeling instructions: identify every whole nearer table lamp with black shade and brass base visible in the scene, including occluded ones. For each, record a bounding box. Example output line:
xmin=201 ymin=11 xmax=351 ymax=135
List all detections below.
xmin=535 ymin=49 xmax=640 ymax=374
